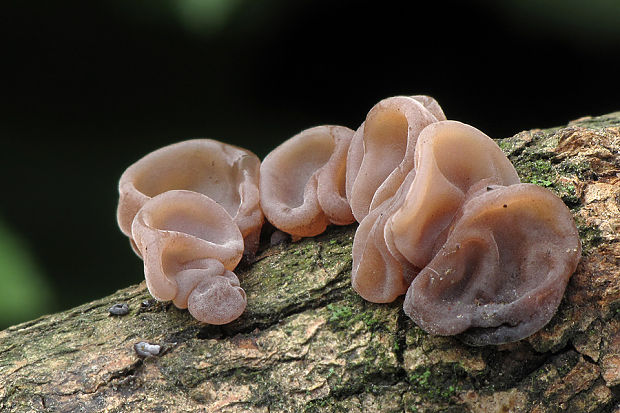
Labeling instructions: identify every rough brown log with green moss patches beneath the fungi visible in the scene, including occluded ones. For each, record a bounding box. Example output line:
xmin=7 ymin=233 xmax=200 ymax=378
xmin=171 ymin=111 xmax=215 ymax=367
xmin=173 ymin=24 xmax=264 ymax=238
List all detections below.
xmin=0 ymin=112 xmax=620 ymax=412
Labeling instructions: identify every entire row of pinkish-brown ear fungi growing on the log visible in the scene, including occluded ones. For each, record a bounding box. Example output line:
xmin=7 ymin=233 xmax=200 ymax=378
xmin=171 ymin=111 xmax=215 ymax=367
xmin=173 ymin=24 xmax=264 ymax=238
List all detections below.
xmin=118 ymin=96 xmax=581 ymax=345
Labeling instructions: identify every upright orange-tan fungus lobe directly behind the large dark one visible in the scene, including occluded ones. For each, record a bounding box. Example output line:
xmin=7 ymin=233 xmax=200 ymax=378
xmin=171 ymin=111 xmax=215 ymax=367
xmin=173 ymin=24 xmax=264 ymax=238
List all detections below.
xmin=385 ymin=121 xmax=520 ymax=268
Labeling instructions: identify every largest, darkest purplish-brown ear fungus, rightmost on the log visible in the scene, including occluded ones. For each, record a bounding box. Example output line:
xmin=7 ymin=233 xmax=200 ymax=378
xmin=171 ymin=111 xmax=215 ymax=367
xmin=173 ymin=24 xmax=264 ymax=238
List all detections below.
xmin=404 ymin=184 xmax=581 ymax=345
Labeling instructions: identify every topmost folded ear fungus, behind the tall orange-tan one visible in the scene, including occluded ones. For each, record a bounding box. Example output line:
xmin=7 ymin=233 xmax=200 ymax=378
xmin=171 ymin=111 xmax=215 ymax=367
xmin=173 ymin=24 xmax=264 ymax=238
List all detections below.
xmin=346 ymin=96 xmax=445 ymax=222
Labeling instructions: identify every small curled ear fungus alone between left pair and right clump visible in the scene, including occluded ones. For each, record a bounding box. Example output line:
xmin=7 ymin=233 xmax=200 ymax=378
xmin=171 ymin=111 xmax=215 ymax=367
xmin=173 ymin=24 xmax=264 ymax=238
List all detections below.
xmin=260 ymin=126 xmax=354 ymax=237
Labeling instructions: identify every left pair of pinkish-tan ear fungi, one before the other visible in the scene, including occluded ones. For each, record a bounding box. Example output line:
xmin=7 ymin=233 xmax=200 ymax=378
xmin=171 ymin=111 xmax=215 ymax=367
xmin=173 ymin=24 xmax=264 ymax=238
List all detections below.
xmin=117 ymin=139 xmax=264 ymax=324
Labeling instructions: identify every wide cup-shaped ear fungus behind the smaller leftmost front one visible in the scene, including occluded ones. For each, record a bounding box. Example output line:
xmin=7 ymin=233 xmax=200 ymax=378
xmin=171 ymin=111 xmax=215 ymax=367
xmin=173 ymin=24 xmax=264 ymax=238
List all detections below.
xmin=117 ymin=139 xmax=263 ymax=252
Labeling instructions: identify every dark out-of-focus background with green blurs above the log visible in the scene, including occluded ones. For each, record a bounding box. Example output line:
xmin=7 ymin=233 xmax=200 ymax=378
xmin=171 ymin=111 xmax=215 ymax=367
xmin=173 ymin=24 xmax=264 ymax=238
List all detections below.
xmin=0 ymin=0 xmax=620 ymax=328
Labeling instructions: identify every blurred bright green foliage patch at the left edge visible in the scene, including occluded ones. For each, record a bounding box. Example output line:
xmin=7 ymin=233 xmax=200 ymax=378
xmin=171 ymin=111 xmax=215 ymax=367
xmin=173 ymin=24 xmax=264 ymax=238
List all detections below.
xmin=0 ymin=216 xmax=53 ymax=329
